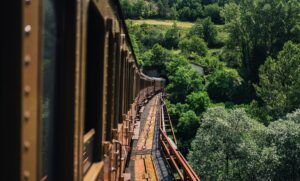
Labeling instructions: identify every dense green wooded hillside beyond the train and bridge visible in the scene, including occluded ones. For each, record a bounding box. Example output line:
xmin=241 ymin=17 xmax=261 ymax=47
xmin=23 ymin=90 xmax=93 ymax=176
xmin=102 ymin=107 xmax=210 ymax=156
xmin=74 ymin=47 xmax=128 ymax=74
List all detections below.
xmin=121 ymin=0 xmax=300 ymax=181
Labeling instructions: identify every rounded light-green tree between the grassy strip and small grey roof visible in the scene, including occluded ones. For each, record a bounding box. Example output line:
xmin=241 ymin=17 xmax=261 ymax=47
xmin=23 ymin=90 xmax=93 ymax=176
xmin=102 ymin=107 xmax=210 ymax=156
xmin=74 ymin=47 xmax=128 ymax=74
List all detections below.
xmin=179 ymin=36 xmax=207 ymax=56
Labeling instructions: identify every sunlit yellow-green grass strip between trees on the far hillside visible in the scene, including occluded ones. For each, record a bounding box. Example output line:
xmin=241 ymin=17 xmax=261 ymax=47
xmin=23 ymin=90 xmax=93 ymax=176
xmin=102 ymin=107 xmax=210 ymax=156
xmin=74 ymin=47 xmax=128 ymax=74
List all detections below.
xmin=132 ymin=19 xmax=193 ymax=28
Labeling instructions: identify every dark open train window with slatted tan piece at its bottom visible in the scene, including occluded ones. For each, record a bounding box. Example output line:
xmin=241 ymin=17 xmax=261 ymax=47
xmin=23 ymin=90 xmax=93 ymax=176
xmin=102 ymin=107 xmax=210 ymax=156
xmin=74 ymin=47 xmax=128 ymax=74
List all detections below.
xmin=83 ymin=3 xmax=105 ymax=173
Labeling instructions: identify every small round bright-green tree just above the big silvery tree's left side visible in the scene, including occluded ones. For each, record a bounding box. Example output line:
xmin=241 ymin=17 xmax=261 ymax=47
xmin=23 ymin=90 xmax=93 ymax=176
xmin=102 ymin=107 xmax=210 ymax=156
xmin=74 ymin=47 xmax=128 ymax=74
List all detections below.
xmin=186 ymin=91 xmax=210 ymax=115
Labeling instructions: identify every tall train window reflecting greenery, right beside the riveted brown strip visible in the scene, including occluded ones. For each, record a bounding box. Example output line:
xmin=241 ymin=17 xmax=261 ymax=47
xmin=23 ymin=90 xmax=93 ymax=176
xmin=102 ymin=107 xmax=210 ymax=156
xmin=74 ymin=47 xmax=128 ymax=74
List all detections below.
xmin=41 ymin=0 xmax=57 ymax=180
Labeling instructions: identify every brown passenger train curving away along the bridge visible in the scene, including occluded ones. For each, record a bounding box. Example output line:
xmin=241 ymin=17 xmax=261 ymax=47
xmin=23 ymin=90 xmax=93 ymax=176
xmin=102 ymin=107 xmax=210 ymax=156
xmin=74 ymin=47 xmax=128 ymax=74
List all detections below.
xmin=0 ymin=0 xmax=164 ymax=180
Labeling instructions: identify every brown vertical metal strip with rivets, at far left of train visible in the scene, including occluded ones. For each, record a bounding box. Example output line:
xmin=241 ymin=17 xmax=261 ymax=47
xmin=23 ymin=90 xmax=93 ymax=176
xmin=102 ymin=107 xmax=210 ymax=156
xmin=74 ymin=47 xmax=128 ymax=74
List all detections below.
xmin=21 ymin=1 xmax=41 ymax=180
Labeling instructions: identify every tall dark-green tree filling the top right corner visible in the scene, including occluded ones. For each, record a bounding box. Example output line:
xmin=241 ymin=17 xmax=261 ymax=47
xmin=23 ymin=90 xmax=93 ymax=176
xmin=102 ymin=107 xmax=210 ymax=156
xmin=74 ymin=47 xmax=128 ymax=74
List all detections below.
xmin=221 ymin=0 xmax=300 ymax=83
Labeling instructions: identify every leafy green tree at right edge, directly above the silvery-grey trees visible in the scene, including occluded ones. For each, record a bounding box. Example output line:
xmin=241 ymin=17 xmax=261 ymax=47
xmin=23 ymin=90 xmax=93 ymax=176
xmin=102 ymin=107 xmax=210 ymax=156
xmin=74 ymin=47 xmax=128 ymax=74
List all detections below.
xmin=256 ymin=42 xmax=300 ymax=119
